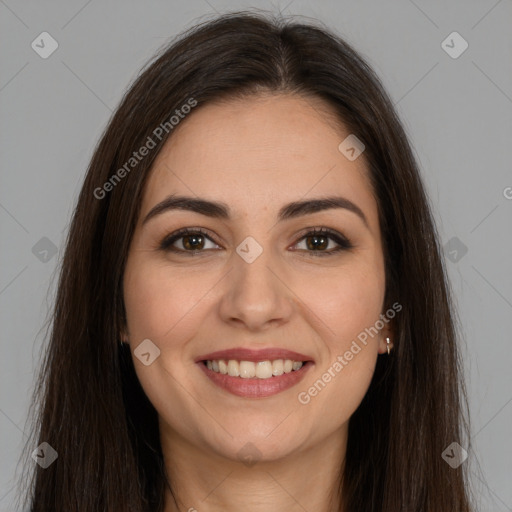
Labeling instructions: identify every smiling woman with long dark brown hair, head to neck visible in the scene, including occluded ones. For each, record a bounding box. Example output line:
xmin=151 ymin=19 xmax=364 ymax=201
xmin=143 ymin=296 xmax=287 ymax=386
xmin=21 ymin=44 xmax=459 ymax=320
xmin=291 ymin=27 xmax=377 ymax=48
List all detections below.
xmin=17 ymin=9 xmax=470 ymax=512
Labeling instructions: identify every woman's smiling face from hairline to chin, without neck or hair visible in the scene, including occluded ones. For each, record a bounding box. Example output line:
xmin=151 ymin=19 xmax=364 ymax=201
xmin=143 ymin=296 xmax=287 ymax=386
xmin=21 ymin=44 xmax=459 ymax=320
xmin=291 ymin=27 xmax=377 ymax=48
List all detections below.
xmin=124 ymin=95 xmax=390 ymax=460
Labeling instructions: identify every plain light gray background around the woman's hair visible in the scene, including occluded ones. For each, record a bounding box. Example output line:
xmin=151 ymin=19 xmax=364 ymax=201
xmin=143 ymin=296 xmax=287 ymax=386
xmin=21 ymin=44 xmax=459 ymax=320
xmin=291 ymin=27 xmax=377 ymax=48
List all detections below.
xmin=0 ymin=0 xmax=512 ymax=512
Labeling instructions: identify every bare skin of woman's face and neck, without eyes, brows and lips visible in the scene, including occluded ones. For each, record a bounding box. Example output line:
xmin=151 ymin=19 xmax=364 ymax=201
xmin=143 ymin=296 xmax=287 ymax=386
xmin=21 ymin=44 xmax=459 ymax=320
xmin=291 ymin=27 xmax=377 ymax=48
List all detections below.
xmin=122 ymin=95 xmax=393 ymax=512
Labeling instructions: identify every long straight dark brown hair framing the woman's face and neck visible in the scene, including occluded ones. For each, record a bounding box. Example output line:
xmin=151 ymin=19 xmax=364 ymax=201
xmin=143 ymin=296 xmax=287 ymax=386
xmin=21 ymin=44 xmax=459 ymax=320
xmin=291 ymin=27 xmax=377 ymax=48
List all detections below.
xmin=16 ymin=12 xmax=470 ymax=512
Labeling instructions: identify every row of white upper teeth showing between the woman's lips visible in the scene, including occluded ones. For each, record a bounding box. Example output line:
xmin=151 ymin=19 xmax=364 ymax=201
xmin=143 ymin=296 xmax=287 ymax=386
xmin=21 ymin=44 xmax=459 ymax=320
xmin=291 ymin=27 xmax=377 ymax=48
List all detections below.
xmin=206 ymin=359 xmax=304 ymax=379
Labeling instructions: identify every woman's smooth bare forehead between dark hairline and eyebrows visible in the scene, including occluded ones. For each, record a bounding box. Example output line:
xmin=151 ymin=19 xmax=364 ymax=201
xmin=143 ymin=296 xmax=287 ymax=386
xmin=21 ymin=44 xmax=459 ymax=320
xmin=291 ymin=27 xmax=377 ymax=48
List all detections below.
xmin=142 ymin=95 xmax=378 ymax=229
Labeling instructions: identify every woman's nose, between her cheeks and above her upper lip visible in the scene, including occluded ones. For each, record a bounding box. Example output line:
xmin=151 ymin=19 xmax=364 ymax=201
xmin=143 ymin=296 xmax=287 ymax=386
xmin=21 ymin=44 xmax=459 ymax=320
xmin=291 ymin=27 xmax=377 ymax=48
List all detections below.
xmin=219 ymin=251 xmax=293 ymax=332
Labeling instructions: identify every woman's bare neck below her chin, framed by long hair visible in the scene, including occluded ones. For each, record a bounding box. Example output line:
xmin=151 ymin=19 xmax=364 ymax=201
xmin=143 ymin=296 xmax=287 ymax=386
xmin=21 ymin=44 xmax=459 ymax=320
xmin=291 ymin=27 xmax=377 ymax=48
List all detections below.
xmin=161 ymin=425 xmax=348 ymax=512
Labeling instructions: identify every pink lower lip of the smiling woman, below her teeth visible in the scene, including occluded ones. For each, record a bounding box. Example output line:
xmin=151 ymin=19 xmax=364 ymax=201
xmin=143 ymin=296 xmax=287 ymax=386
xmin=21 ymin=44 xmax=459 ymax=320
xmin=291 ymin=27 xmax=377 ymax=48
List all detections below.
xmin=197 ymin=361 xmax=312 ymax=398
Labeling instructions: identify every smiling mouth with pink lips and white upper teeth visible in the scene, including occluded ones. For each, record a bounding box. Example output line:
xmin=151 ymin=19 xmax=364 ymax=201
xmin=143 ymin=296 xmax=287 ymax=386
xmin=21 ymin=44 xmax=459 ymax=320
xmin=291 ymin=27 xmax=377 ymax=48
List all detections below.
xmin=196 ymin=349 xmax=314 ymax=398
